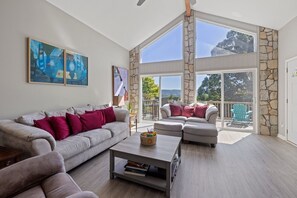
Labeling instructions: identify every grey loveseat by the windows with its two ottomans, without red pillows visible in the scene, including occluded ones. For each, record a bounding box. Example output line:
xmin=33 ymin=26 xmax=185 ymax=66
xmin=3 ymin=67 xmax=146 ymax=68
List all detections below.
xmin=154 ymin=104 xmax=218 ymax=147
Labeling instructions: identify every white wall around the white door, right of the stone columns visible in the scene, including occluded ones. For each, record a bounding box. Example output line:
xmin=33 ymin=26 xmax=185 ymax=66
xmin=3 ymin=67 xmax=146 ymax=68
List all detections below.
xmin=278 ymin=17 xmax=297 ymax=136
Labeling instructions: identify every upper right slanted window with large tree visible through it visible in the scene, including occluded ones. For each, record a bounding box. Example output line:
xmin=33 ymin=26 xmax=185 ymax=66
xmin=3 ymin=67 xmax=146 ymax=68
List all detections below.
xmin=196 ymin=20 xmax=256 ymax=58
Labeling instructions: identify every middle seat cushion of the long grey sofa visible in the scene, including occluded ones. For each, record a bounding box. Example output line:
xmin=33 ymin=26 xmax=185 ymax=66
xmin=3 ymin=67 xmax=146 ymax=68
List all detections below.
xmin=78 ymin=129 xmax=112 ymax=146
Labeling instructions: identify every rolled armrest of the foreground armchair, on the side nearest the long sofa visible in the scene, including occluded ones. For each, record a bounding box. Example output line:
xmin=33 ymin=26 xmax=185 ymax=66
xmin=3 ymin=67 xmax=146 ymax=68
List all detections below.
xmin=0 ymin=152 xmax=65 ymax=197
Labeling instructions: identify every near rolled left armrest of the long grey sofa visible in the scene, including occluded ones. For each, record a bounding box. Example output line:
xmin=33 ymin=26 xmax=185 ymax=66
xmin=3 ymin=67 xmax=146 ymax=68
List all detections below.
xmin=0 ymin=120 xmax=56 ymax=155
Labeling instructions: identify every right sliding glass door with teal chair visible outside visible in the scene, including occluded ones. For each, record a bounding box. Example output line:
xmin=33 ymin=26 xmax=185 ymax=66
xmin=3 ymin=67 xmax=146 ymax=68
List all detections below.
xmin=196 ymin=70 xmax=257 ymax=131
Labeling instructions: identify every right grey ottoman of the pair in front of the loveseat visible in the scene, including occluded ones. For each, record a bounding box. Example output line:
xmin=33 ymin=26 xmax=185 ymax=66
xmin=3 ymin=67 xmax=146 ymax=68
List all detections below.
xmin=183 ymin=122 xmax=218 ymax=148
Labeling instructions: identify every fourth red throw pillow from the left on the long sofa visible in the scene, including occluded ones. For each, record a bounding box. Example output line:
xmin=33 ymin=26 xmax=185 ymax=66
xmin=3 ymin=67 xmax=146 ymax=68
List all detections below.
xmin=80 ymin=112 xmax=102 ymax=131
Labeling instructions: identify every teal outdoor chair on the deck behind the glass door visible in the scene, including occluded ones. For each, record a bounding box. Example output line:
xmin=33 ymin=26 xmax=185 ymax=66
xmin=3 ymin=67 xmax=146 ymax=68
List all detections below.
xmin=229 ymin=104 xmax=253 ymax=127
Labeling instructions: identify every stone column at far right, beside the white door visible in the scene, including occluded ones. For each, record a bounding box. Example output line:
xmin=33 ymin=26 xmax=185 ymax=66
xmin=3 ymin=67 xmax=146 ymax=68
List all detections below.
xmin=259 ymin=27 xmax=278 ymax=136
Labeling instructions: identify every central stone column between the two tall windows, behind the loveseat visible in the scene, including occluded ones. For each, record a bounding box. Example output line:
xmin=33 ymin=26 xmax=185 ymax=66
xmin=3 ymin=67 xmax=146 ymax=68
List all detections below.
xmin=183 ymin=10 xmax=196 ymax=104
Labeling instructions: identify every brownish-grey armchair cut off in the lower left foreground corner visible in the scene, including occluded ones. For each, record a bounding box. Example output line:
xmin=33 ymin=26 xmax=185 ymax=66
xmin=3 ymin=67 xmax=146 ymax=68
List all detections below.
xmin=0 ymin=152 xmax=98 ymax=198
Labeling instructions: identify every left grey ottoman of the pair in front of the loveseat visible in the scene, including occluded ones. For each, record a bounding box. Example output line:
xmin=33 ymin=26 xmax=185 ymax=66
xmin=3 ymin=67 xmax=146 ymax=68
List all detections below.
xmin=154 ymin=119 xmax=184 ymax=137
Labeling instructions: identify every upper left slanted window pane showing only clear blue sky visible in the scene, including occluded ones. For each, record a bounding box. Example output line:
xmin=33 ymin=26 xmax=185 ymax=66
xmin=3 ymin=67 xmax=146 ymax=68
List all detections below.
xmin=140 ymin=23 xmax=183 ymax=63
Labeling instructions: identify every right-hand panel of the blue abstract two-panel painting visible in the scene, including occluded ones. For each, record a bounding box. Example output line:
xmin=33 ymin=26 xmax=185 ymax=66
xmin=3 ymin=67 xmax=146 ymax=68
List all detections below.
xmin=66 ymin=51 xmax=88 ymax=86
